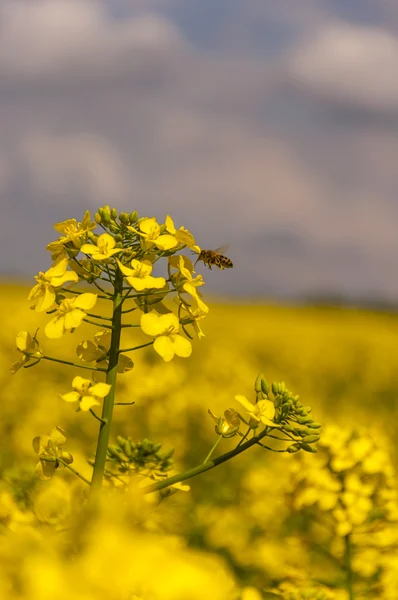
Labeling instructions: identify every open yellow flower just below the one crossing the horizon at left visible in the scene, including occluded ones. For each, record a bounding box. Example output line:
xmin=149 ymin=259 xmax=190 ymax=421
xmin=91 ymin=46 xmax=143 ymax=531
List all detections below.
xmin=44 ymin=292 xmax=97 ymax=339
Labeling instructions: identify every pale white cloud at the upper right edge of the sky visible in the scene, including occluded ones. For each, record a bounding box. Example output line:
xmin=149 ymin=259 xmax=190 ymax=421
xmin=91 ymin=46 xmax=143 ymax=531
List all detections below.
xmin=288 ymin=23 xmax=398 ymax=112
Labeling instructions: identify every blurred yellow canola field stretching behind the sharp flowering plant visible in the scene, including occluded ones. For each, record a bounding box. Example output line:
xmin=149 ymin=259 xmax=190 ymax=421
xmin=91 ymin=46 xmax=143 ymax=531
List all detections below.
xmin=0 ymin=284 xmax=398 ymax=600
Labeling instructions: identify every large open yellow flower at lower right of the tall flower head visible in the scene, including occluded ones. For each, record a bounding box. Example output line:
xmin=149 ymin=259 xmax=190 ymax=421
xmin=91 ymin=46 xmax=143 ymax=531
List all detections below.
xmin=141 ymin=312 xmax=192 ymax=362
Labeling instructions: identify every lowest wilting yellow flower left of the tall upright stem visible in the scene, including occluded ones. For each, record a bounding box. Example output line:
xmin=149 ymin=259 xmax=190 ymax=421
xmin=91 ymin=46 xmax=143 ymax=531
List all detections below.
xmin=33 ymin=426 xmax=73 ymax=479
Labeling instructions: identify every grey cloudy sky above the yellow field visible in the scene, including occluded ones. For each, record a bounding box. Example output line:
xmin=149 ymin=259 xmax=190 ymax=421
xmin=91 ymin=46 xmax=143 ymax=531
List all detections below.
xmin=0 ymin=0 xmax=398 ymax=300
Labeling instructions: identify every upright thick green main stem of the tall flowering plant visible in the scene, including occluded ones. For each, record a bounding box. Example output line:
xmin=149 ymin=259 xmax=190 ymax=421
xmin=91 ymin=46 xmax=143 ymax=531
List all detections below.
xmin=90 ymin=269 xmax=123 ymax=495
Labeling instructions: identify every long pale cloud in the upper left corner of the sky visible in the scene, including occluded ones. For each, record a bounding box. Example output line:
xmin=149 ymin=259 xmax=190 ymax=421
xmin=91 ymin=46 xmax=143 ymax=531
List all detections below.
xmin=0 ymin=0 xmax=183 ymax=80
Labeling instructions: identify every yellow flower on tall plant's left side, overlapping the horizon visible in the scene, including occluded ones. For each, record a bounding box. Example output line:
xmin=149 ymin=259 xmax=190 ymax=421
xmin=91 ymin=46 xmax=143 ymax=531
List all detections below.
xmin=28 ymin=258 xmax=79 ymax=312
